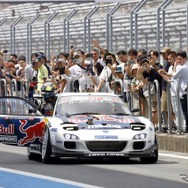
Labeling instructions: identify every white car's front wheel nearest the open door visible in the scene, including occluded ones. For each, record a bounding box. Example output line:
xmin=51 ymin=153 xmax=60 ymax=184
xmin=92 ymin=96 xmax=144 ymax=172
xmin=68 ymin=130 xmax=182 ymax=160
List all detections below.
xmin=42 ymin=129 xmax=52 ymax=164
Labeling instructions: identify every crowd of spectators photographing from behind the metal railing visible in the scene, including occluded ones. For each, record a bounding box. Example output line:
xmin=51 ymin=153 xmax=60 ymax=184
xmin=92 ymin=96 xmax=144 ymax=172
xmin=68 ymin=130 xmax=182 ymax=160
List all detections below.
xmin=0 ymin=40 xmax=188 ymax=132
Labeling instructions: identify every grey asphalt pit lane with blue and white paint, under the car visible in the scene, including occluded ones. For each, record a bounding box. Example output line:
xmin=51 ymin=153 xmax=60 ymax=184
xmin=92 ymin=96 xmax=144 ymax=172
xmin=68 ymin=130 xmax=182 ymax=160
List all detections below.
xmin=0 ymin=144 xmax=188 ymax=188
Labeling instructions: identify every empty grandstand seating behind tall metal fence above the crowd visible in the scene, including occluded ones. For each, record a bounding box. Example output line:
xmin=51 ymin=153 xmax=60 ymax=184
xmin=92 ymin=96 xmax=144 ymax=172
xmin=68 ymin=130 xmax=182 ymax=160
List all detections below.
xmin=0 ymin=0 xmax=188 ymax=62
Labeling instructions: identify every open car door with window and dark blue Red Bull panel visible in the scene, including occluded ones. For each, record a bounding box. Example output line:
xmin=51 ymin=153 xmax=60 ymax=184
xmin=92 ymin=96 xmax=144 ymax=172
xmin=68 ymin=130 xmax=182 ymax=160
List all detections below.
xmin=0 ymin=97 xmax=45 ymax=146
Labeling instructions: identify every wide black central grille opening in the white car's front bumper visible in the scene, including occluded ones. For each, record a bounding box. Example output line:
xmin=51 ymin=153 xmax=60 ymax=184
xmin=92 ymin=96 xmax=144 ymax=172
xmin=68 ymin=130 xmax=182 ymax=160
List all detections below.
xmin=86 ymin=141 xmax=127 ymax=152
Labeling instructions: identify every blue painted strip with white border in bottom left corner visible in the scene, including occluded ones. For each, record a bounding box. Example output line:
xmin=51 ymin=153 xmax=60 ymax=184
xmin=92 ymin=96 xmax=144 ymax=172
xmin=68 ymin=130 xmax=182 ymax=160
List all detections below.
xmin=0 ymin=167 xmax=102 ymax=188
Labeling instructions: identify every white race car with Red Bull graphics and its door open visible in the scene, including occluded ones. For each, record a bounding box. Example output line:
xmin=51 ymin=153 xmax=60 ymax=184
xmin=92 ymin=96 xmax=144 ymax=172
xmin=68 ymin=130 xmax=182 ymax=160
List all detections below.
xmin=0 ymin=93 xmax=158 ymax=163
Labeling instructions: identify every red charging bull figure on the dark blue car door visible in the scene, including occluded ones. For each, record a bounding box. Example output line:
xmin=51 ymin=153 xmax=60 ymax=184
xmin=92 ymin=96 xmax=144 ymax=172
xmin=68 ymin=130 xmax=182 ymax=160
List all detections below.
xmin=18 ymin=120 xmax=45 ymax=145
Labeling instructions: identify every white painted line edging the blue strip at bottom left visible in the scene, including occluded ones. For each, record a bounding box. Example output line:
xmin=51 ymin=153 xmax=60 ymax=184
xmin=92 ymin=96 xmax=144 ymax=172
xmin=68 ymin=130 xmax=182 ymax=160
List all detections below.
xmin=0 ymin=167 xmax=102 ymax=188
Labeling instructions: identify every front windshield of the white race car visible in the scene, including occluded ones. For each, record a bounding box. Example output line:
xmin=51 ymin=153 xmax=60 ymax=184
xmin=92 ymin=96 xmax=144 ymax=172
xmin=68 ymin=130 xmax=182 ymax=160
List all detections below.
xmin=55 ymin=95 xmax=130 ymax=116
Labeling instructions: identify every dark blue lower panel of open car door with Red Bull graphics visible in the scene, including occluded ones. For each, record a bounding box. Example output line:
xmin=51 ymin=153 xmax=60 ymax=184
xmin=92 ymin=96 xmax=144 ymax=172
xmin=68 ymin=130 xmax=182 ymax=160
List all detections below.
xmin=0 ymin=116 xmax=45 ymax=146
